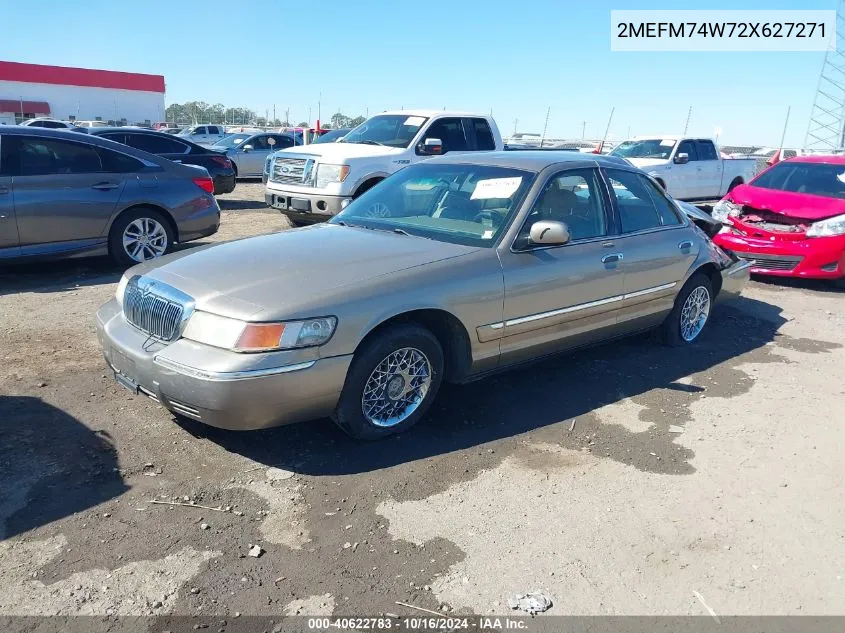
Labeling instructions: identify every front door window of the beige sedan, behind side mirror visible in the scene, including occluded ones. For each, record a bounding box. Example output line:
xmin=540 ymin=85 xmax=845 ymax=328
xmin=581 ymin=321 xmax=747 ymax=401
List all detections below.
xmin=521 ymin=169 xmax=607 ymax=240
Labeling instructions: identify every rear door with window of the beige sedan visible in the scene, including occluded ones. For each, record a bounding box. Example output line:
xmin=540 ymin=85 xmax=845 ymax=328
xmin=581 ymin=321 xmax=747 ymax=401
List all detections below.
xmin=604 ymin=169 xmax=700 ymax=329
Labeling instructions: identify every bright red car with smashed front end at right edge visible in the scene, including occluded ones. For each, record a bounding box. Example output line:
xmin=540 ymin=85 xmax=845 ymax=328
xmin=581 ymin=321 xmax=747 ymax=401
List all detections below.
xmin=713 ymin=156 xmax=845 ymax=287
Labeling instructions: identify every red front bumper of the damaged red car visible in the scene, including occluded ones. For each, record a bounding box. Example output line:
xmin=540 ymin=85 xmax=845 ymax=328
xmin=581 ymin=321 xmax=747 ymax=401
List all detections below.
xmin=713 ymin=233 xmax=845 ymax=279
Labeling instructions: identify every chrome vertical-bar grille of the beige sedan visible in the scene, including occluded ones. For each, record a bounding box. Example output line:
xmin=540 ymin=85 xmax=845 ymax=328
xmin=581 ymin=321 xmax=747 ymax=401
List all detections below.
xmin=123 ymin=277 xmax=185 ymax=341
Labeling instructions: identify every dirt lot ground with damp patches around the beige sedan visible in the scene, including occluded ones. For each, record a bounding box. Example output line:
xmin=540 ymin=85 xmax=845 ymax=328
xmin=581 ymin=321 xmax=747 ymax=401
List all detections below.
xmin=0 ymin=183 xmax=845 ymax=628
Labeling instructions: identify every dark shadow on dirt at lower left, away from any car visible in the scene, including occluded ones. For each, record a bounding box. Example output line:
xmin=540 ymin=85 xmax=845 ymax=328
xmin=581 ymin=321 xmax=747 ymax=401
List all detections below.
xmin=0 ymin=396 xmax=128 ymax=540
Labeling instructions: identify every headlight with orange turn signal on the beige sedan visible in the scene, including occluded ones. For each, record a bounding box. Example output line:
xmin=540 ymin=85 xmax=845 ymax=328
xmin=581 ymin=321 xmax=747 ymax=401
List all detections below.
xmin=182 ymin=311 xmax=337 ymax=352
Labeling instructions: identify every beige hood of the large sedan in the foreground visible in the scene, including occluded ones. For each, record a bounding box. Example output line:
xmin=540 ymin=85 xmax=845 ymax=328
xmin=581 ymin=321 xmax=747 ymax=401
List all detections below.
xmin=141 ymin=224 xmax=477 ymax=320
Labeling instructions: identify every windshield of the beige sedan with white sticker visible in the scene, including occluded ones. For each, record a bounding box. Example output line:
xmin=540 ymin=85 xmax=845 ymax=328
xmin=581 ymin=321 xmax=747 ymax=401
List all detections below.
xmin=331 ymin=164 xmax=535 ymax=247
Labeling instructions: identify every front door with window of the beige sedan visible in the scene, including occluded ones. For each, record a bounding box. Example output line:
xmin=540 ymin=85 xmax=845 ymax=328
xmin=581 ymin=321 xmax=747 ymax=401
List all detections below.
xmin=500 ymin=168 xmax=623 ymax=364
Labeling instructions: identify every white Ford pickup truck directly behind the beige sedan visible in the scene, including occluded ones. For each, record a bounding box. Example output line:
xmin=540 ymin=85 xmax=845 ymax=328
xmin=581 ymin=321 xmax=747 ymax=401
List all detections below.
xmin=264 ymin=110 xmax=503 ymax=224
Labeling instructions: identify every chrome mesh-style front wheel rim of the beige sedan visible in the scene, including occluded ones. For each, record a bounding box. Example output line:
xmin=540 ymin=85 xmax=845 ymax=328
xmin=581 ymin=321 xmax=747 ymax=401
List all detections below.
xmin=361 ymin=347 xmax=431 ymax=427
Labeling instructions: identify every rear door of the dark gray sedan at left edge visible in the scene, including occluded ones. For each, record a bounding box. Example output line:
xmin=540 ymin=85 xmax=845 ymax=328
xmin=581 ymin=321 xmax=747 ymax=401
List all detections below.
xmin=10 ymin=136 xmax=124 ymax=250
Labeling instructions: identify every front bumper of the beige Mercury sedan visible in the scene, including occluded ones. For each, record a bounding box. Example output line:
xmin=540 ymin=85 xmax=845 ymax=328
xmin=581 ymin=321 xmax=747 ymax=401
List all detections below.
xmin=97 ymin=299 xmax=352 ymax=430
